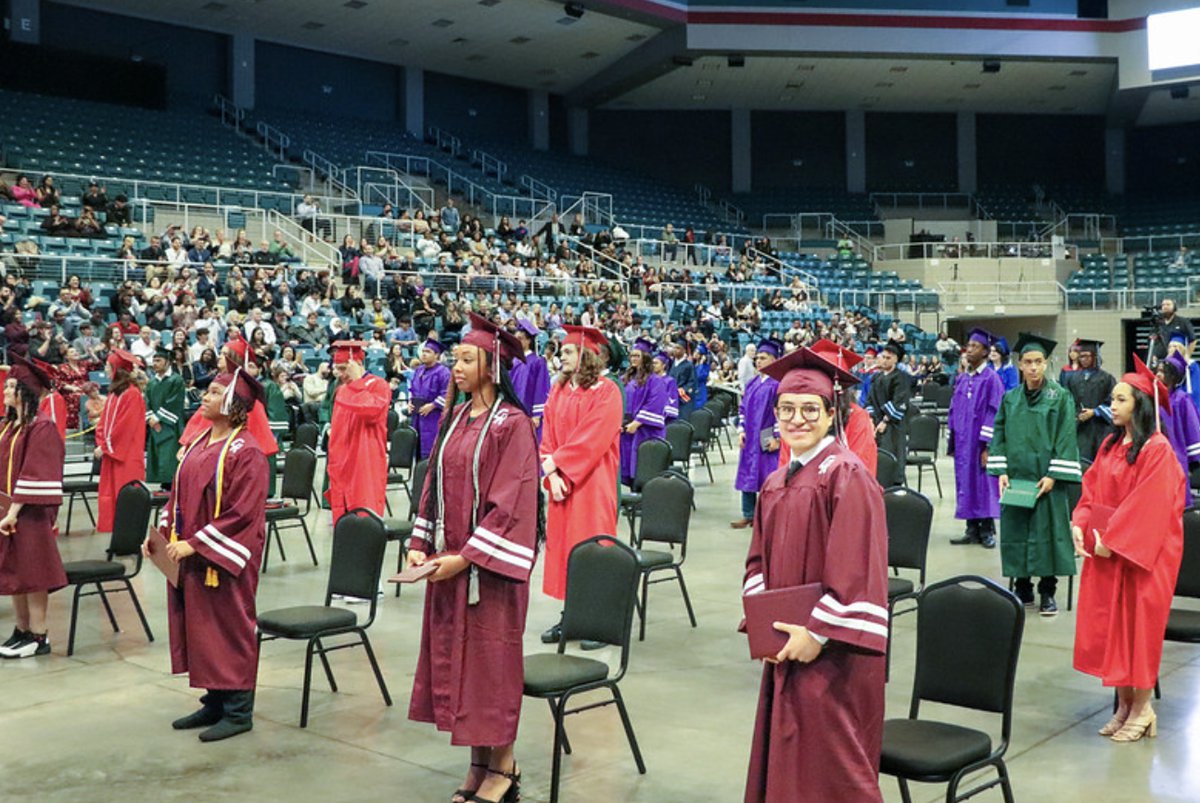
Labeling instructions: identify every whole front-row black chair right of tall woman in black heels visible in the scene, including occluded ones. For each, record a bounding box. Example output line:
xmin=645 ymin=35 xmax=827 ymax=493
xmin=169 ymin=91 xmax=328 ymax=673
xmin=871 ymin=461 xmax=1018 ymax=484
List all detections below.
xmin=524 ymin=535 xmax=646 ymax=803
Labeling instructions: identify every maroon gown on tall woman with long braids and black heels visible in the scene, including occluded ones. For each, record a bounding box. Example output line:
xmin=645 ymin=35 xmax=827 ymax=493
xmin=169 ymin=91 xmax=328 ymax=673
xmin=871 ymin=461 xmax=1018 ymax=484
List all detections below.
xmin=408 ymin=402 xmax=538 ymax=747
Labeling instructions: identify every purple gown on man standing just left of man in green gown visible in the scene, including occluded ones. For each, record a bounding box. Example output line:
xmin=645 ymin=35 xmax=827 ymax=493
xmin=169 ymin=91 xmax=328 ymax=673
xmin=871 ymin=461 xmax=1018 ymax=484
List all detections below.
xmin=948 ymin=365 xmax=1004 ymax=519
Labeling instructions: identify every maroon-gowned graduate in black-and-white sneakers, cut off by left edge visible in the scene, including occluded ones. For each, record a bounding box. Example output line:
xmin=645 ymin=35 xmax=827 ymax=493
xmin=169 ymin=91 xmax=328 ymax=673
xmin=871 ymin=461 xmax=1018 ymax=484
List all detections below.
xmin=0 ymin=353 xmax=67 ymax=658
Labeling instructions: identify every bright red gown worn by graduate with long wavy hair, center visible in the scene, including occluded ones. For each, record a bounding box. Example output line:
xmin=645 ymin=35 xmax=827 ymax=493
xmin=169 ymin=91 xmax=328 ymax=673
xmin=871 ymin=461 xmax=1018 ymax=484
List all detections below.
xmin=541 ymin=377 xmax=623 ymax=599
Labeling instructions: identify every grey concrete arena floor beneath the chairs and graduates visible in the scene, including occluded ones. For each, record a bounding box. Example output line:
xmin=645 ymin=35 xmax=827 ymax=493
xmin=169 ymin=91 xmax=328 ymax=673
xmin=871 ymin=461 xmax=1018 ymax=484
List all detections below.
xmin=0 ymin=444 xmax=1200 ymax=803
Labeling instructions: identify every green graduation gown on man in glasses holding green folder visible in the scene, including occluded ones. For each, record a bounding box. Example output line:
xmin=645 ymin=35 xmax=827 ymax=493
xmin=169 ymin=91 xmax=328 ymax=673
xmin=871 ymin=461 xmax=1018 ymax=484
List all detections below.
xmin=988 ymin=379 xmax=1084 ymax=577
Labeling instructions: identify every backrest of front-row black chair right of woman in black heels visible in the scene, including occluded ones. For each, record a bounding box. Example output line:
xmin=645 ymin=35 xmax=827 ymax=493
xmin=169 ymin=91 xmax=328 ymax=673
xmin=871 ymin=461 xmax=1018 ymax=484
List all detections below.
xmin=558 ymin=535 xmax=641 ymax=670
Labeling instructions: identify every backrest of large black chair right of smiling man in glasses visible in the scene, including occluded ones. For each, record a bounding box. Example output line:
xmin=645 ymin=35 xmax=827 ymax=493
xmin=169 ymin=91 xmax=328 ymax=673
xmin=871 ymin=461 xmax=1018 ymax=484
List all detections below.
xmin=910 ymin=575 xmax=1025 ymax=741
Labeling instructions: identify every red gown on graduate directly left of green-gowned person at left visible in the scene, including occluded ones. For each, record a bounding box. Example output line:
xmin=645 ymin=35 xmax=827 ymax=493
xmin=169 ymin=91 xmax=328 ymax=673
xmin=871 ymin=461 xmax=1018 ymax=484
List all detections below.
xmin=96 ymin=384 xmax=146 ymax=533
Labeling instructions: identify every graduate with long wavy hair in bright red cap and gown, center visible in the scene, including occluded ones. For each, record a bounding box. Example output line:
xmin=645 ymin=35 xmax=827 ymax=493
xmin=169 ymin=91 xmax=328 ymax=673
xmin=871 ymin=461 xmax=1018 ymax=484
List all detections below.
xmin=541 ymin=326 xmax=623 ymax=643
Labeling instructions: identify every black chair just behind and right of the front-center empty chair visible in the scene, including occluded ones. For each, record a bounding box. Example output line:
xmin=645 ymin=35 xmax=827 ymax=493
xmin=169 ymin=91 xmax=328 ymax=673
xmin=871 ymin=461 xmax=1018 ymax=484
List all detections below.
xmin=634 ymin=475 xmax=702 ymax=641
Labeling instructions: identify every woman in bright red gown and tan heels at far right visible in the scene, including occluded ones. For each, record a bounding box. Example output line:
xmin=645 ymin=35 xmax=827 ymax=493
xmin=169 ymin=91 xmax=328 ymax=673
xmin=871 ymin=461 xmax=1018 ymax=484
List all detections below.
xmin=1070 ymin=355 xmax=1183 ymax=742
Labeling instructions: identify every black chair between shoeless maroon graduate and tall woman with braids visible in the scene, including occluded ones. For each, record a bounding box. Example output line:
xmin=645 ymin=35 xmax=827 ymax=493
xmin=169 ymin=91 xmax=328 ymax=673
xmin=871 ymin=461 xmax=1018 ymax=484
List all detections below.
xmin=258 ymin=508 xmax=391 ymax=727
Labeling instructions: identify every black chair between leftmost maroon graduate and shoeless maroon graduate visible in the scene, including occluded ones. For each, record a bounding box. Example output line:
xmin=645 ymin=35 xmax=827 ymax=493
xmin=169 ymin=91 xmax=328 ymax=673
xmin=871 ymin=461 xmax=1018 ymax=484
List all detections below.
xmin=62 ymin=481 xmax=154 ymax=655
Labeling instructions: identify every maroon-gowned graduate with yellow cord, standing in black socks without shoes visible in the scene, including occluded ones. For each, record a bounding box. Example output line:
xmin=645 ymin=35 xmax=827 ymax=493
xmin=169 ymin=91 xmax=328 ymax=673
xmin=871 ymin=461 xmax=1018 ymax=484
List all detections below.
xmin=152 ymin=368 xmax=268 ymax=742
